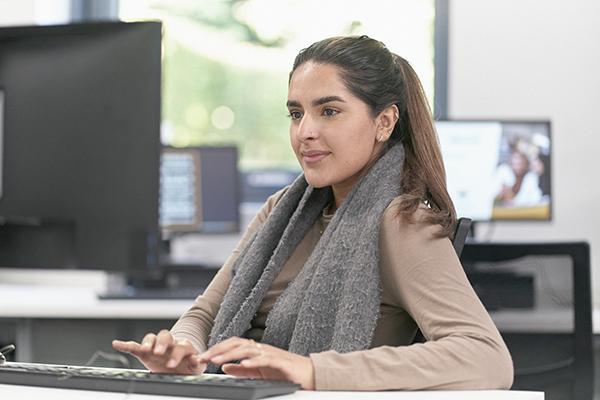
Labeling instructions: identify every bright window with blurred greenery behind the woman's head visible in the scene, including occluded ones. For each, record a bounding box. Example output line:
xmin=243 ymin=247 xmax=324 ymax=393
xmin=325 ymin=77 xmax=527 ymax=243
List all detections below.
xmin=119 ymin=0 xmax=435 ymax=170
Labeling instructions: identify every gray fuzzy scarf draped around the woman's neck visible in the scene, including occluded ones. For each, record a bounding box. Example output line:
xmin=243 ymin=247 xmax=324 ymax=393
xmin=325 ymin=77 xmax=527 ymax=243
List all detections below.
xmin=209 ymin=144 xmax=404 ymax=372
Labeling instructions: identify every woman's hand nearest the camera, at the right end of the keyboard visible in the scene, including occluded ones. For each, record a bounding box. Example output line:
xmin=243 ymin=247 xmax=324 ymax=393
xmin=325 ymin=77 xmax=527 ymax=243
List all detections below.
xmin=198 ymin=337 xmax=315 ymax=390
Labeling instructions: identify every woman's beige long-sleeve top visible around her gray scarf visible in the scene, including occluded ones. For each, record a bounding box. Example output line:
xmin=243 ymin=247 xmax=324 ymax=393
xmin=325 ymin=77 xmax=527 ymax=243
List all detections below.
xmin=171 ymin=190 xmax=513 ymax=390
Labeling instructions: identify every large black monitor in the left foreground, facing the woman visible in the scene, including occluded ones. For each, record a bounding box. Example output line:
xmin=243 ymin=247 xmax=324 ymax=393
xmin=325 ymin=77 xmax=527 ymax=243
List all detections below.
xmin=0 ymin=22 xmax=161 ymax=271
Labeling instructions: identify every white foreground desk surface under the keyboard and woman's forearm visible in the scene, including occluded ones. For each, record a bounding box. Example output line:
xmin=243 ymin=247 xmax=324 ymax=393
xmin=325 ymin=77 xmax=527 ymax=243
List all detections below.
xmin=0 ymin=384 xmax=544 ymax=400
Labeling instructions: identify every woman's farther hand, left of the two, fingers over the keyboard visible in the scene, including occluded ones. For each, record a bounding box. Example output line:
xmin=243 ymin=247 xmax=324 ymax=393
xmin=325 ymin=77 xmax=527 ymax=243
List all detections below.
xmin=112 ymin=329 xmax=206 ymax=375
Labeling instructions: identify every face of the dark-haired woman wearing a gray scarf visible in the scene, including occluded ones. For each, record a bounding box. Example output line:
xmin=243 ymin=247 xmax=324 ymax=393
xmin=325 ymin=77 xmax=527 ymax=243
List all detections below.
xmin=287 ymin=62 xmax=382 ymax=193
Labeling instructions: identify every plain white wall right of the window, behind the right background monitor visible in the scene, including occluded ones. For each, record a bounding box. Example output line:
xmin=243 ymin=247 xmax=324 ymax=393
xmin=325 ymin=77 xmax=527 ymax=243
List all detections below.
xmin=448 ymin=0 xmax=600 ymax=307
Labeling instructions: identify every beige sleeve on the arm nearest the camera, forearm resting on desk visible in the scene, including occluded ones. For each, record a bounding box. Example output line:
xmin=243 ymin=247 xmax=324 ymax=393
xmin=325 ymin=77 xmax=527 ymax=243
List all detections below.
xmin=310 ymin=208 xmax=513 ymax=390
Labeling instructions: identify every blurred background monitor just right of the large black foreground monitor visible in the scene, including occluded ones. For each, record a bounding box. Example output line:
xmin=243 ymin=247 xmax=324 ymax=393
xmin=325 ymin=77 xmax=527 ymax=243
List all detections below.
xmin=160 ymin=146 xmax=240 ymax=235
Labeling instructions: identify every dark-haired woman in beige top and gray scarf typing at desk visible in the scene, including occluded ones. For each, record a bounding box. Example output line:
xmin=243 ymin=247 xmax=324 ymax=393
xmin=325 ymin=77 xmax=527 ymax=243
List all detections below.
xmin=113 ymin=36 xmax=512 ymax=390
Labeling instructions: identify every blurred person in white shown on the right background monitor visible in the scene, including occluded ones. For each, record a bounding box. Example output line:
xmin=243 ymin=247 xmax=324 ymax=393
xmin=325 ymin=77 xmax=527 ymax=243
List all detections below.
xmin=495 ymin=148 xmax=543 ymax=207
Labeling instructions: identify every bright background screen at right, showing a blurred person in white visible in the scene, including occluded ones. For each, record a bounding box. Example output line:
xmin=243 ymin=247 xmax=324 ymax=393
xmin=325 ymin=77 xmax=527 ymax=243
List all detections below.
xmin=436 ymin=120 xmax=552 ymax=221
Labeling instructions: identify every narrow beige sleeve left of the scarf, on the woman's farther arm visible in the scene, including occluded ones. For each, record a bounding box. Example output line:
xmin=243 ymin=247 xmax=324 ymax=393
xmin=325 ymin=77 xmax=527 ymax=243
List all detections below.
xmin=171 ymin=188 xmax=287 ymax=351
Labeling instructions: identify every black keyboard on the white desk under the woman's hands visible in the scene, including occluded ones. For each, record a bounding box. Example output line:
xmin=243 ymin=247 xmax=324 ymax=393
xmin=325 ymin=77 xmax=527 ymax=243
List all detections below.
xmin=0 ymin=362 xmax=300 ymax=400
